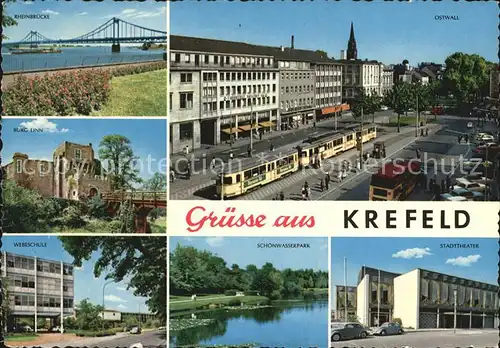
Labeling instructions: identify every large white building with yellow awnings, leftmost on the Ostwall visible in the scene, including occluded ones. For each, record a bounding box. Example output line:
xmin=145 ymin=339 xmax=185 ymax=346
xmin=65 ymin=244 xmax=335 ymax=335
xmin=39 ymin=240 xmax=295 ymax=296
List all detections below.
xmin=169 ymin=35 xmax=279 ymax=153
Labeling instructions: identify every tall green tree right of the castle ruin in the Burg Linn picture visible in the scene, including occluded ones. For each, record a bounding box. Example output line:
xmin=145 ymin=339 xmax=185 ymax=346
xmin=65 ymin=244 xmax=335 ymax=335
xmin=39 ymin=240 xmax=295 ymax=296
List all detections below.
xmin=99 ymin=134 xmax=142 ymax=190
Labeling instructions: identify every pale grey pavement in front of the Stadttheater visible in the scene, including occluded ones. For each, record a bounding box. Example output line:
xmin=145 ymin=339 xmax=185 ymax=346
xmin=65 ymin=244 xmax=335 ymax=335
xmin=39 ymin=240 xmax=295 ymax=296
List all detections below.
xmin=330 ymin=330 xmax=498 ymax=348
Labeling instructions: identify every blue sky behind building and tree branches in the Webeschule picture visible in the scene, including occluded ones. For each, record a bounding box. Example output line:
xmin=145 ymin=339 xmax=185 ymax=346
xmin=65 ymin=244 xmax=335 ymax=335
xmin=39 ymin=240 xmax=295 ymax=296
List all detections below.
xmin=2 ymin=236 xmax=149 ymax=313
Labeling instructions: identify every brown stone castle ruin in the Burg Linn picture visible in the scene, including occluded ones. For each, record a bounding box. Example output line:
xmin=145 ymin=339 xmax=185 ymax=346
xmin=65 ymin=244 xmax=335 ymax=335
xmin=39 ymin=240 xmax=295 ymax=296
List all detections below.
xmin=3 ymin=141 xmax=111 ymax=200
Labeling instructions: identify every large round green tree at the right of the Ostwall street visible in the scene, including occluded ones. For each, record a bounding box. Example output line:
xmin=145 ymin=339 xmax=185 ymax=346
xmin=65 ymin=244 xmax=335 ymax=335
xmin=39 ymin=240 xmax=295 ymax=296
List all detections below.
xmin=443 ymin=52 xmax=489 ymax=107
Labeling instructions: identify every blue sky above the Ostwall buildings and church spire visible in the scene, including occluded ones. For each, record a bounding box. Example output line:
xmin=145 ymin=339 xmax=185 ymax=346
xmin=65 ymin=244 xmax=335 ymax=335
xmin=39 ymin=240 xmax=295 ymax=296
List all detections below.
xmin=170 ymin=0 xmax=498 ymax=65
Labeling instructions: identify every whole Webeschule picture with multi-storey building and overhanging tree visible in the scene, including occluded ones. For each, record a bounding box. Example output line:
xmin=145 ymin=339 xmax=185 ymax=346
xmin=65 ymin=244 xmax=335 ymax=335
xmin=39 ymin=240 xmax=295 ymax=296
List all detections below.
xmin=0 ymin=236 xmax=167 ymax=347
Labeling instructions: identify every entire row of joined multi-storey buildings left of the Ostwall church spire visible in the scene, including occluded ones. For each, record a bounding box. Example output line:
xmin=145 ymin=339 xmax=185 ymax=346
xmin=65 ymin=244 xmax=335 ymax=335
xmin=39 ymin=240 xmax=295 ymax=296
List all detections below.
xmin=169 ymin=35 xmax=342 ymax=153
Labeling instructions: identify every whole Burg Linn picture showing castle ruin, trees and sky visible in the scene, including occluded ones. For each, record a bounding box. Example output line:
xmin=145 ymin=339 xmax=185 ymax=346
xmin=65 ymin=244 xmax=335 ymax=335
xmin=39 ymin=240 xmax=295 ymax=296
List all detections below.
xmin=2 ymin=118 xmax=167 ymax=233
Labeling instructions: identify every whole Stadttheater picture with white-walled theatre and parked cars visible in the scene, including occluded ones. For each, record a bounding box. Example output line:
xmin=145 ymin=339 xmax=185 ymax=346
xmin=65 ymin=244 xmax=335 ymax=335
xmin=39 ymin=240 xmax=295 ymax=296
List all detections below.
xmin=330 ymin=238 xmax=500 ymax=347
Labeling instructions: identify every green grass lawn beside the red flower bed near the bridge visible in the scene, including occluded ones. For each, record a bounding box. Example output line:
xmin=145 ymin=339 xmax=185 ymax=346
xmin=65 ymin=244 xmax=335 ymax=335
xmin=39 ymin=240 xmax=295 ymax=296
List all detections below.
xmin=92 ymin=69 xmax=167 ymax=116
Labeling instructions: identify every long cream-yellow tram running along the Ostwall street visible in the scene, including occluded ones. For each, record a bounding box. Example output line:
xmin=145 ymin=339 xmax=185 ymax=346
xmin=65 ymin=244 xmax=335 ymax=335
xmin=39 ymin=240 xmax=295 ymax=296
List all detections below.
xmin=216 ymin=124 xmax=377 ymax=198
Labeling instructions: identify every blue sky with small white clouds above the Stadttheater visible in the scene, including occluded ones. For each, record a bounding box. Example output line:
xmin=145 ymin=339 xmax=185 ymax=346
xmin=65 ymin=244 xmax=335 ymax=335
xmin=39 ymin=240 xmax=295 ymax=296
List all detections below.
xmin=331 ymin=238 xmax=498 ymax=304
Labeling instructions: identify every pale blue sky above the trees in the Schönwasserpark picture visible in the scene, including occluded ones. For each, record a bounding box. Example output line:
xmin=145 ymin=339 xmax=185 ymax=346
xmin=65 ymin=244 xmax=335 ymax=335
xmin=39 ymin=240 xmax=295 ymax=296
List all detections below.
xmin=170 ymin=237 xmax=328 ymax=271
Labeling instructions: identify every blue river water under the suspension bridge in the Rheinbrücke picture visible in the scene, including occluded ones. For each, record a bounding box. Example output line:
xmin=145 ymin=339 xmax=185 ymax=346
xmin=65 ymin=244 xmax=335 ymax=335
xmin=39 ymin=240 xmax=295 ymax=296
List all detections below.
xmin=2 ymin=45 xmax=164 ymax=72
